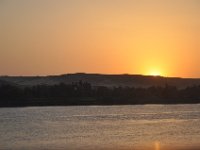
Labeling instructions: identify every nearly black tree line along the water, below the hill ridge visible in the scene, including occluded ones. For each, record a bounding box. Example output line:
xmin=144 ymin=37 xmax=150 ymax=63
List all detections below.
xmin=0 ymin=81 xmax=200 ymax=106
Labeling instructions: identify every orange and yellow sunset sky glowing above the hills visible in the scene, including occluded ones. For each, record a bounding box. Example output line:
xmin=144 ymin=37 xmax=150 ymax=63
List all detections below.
xmin=0 ymin=0 xmax=200 ymax=78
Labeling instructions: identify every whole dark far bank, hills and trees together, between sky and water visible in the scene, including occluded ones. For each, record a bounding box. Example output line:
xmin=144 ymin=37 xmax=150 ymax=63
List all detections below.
xmin=0 ymin=73 xmax=200 ymax=107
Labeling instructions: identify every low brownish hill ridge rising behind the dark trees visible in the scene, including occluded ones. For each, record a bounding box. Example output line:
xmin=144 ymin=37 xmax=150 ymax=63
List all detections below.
xmin=0 ymin=73 xmax=200 ymax=88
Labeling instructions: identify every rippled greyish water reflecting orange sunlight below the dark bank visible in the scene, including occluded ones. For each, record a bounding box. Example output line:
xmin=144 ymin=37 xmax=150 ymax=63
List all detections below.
xmin=0 ymin=104 xmax=200 ymax=150
